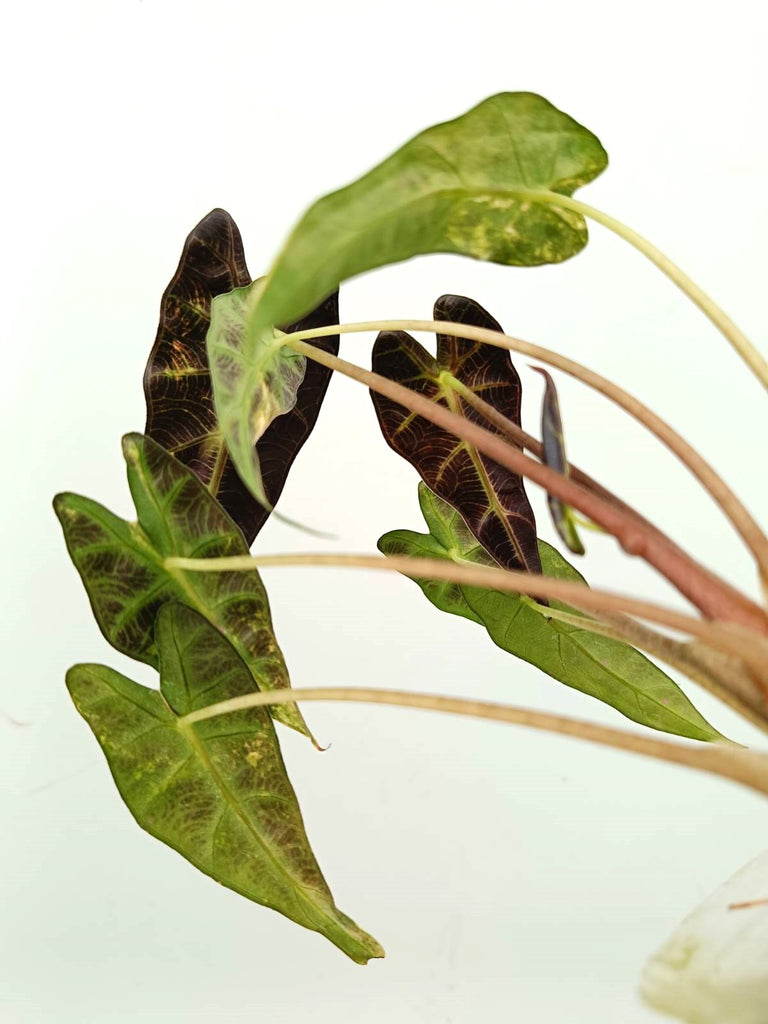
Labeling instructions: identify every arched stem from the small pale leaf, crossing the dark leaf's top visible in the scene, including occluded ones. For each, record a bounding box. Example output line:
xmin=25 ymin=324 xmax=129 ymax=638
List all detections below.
xmin=284 ymin=319 xmax=768 ymax=580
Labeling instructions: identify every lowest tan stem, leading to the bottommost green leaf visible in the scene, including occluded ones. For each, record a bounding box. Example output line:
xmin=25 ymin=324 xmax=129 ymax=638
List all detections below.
xmin=179 ymin=687 xmax=768 ymax=794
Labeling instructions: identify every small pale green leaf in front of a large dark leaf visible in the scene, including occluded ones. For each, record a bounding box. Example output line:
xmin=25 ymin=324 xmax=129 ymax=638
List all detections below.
xmin=206 ymin=282 xmax=309 ymax=508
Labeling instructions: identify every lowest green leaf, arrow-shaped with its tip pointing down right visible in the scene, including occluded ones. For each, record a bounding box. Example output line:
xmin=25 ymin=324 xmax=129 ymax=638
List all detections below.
xmin=67 ymin=602 xmax=384 ymax=964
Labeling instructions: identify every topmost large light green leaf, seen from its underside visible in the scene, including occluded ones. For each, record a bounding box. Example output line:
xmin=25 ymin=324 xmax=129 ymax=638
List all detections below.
xmin=249 ymin=92 xmax=607 ymax=336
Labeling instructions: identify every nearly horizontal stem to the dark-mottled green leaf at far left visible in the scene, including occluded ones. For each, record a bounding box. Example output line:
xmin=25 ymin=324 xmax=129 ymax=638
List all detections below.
xmin=165 ymin=554 xmax=768 ymax=688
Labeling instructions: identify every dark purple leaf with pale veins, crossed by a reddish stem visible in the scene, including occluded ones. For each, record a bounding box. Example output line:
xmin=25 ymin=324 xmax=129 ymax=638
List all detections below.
xmin=371 ymin=295 xmax=541 ymax=572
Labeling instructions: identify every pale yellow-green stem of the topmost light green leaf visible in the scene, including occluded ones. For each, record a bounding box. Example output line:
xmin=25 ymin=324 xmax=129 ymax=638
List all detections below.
xmin=525 ymin=189 xmax=768 ymax=388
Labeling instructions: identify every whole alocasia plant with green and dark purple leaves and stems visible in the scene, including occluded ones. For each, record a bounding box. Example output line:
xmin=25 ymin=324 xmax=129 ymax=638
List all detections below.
xmin=54 ymin=93 xmax=768 ymax=1021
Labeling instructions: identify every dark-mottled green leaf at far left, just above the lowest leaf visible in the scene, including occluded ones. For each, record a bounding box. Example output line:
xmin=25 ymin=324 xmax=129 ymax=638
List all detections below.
xmin=53 ymin=434 xmax=309 ymax=735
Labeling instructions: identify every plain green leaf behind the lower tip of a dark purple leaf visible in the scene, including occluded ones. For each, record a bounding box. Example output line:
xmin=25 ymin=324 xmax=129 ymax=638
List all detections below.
xmin=379 ymin=483 xmax=722 ymax=740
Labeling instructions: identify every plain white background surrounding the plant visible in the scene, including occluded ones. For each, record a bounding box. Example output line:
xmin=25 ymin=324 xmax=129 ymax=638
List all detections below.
xmin=0 ymin=0 xmax=768 ymax=1024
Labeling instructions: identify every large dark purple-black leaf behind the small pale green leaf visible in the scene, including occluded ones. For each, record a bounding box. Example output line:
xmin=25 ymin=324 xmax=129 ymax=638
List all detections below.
xmin=144 ymin=210 xmax=339 ymax=547
